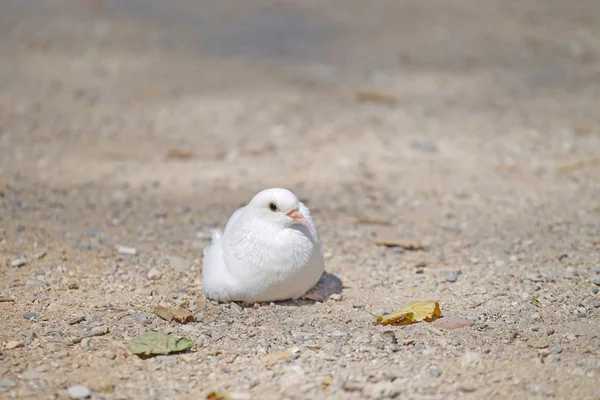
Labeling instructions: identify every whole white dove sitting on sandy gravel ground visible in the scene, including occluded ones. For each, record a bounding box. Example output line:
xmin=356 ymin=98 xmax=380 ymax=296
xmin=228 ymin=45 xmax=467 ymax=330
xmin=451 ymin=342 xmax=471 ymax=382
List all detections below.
xmin=202 ymin=189 xmax=325 ymax=303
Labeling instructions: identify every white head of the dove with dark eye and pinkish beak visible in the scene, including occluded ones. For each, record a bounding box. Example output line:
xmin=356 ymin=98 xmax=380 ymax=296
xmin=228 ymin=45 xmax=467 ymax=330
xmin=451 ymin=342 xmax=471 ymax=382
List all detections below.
xmin=248 ymin=188 xmax=310 ymax=228
